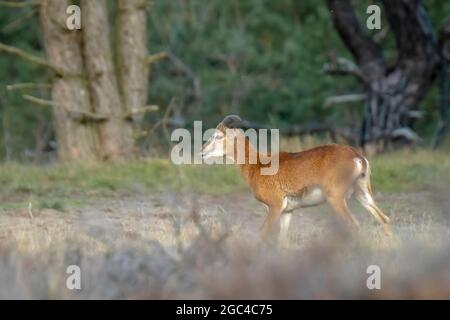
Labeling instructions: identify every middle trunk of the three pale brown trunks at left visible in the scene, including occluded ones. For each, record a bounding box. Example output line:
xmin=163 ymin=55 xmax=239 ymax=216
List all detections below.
xmin=81 ymin=0 xmax=135 ymax=159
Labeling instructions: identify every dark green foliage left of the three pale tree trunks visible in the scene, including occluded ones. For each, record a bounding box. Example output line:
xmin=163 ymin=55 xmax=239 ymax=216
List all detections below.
xmin=0 ymin=7 xmax=51 ymax=159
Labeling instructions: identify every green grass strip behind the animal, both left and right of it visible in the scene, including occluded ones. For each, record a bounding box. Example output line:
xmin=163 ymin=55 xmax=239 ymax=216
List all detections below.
xmin=0 ymin=150 xmax=450 ymax=206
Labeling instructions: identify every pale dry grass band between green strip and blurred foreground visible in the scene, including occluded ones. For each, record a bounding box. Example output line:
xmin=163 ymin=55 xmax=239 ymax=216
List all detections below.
xmin=0 ymin=191 xmax=450 ymax=252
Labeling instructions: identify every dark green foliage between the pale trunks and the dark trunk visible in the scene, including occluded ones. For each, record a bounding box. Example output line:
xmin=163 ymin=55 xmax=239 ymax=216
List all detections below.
xmin=150 ymin=1 xmax=345 ymax=125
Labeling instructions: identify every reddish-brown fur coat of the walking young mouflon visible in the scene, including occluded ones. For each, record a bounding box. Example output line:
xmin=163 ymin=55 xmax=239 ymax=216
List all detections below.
xmin=207 ymin=118 xmax=390 ymax=240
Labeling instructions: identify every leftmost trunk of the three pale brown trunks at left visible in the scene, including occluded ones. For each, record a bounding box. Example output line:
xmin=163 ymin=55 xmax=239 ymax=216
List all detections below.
xmin=40 ymin=0 xmax=98 ymax=161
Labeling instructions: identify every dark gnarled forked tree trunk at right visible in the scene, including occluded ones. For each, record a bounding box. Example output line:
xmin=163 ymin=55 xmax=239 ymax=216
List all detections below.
xmin=327 ymin=0 xmax=439 ymax=152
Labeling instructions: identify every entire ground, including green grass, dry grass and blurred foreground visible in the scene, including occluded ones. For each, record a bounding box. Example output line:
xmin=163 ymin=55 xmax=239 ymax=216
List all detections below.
xmin=0 ymin=151 xmax=450 ymax=299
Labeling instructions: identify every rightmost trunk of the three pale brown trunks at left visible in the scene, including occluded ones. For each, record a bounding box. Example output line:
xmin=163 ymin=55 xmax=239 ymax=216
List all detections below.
xmin=116 ymin=0 xmax=149 ymax=122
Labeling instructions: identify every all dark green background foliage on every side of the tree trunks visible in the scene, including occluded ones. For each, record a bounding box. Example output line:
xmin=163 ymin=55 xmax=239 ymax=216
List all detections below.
xmin=0 ymin=0 xmax=450 ymax=159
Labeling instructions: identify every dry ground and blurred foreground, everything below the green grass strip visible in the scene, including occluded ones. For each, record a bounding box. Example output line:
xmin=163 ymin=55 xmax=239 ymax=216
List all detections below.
xmin=0 ymin=191 xmax=450 ymax=298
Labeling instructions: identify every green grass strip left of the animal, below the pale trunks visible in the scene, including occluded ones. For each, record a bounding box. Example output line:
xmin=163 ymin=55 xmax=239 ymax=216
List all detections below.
xmin=0 ymin=159 xmax=245 ymax=198
